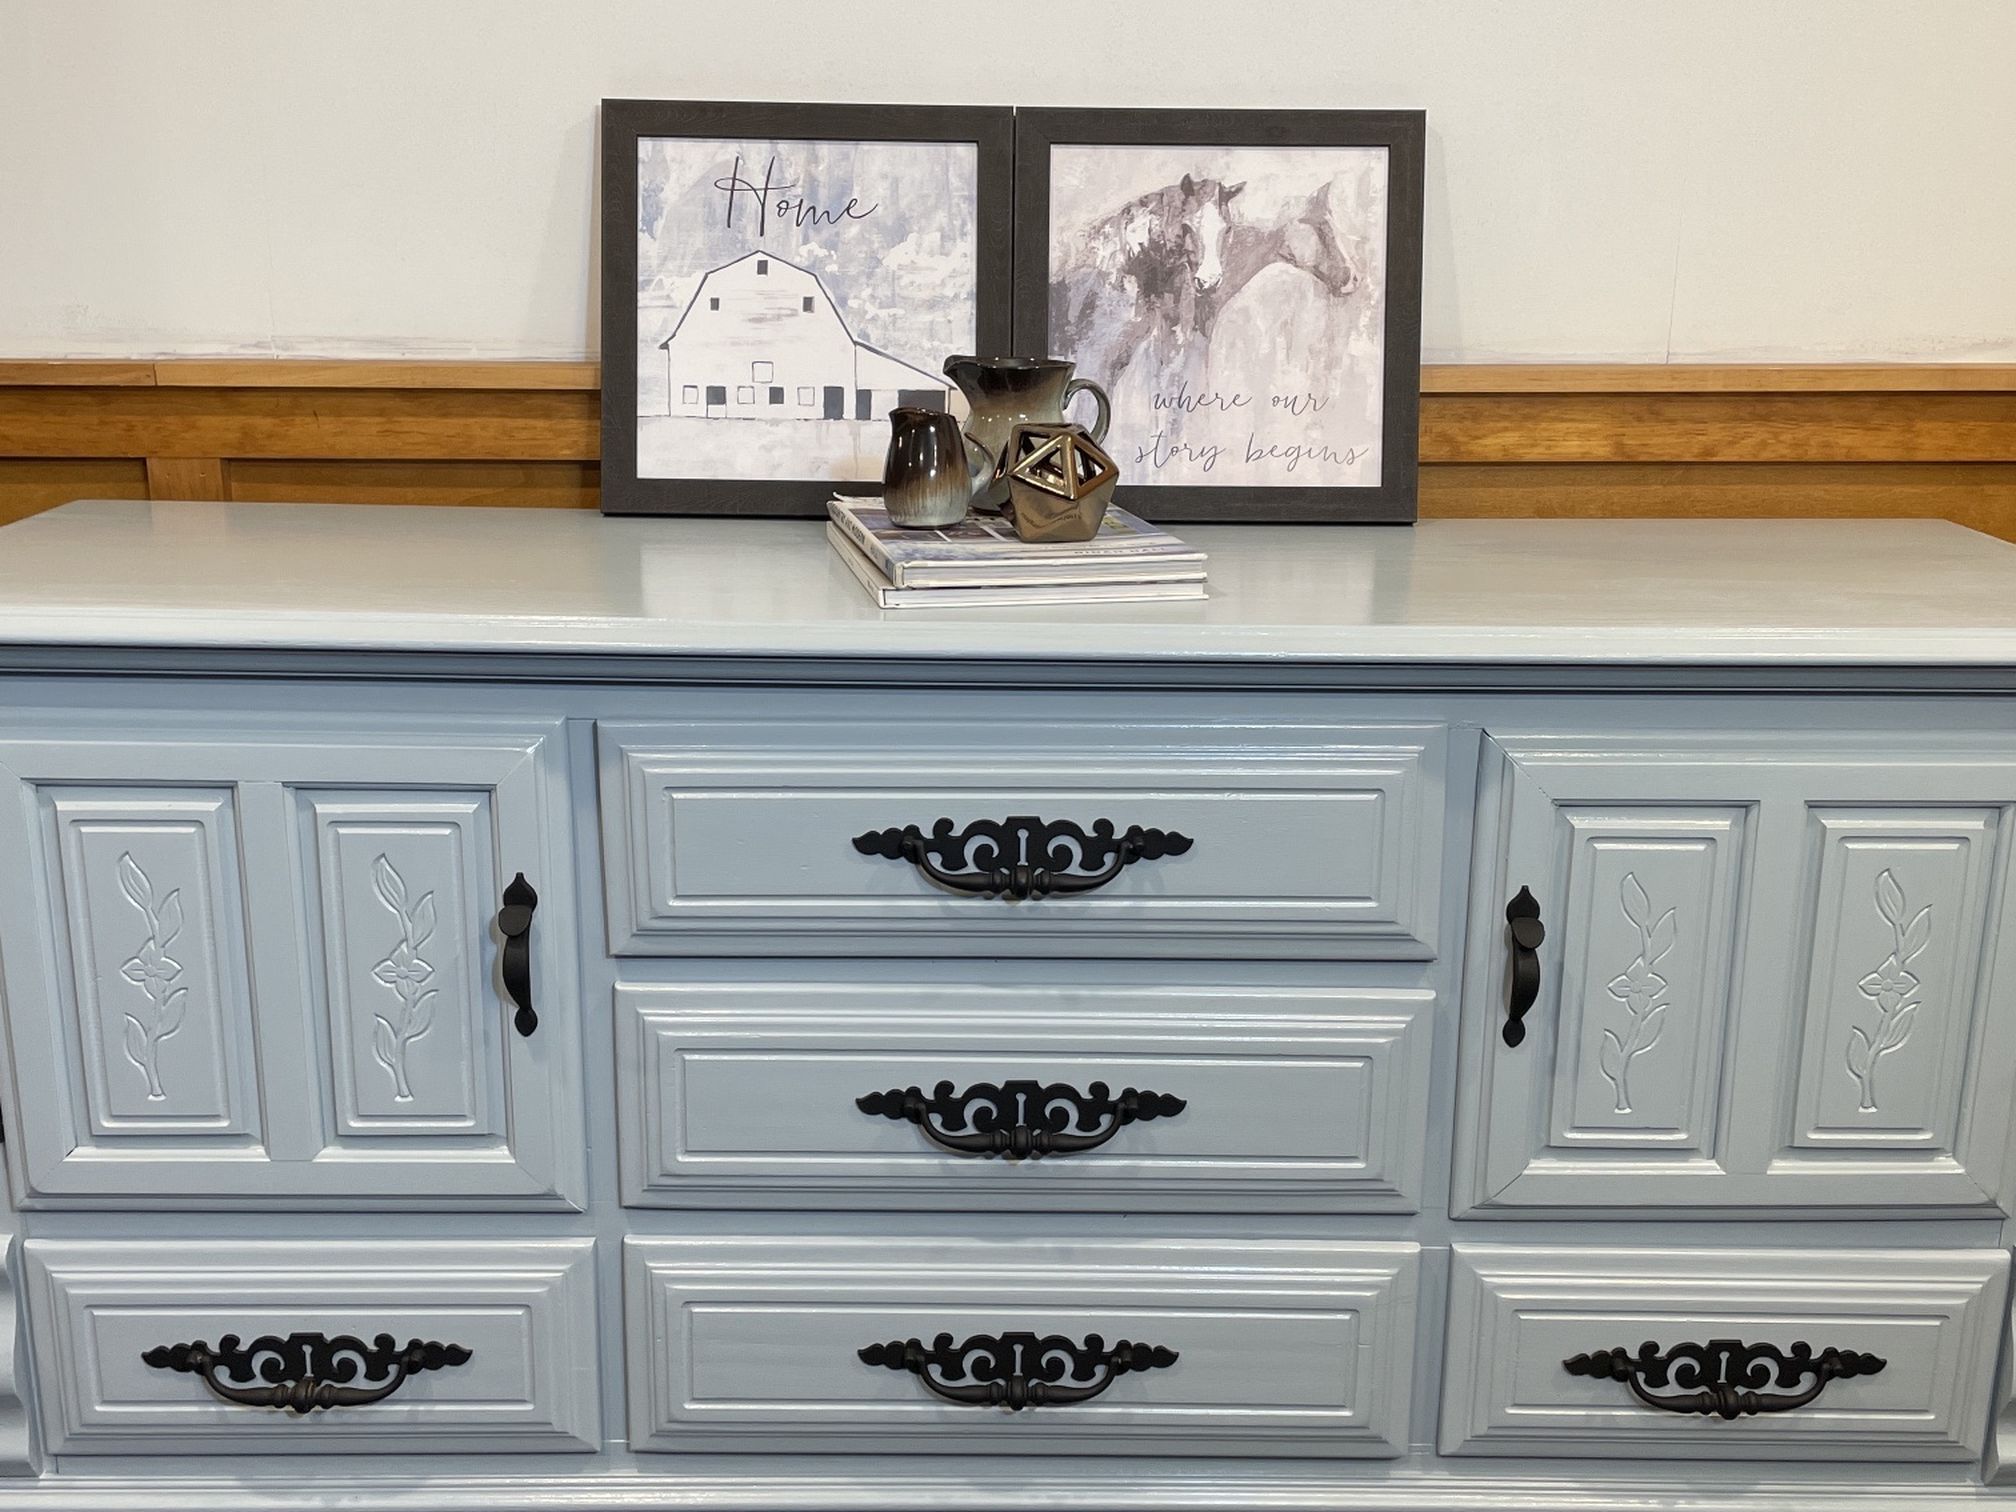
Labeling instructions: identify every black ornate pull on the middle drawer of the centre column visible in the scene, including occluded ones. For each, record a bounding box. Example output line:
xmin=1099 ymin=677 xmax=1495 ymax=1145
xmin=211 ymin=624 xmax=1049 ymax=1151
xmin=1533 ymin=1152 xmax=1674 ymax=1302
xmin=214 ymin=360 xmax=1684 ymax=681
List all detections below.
xmin=855 ymin=1081 xmax=1189 ymax=1159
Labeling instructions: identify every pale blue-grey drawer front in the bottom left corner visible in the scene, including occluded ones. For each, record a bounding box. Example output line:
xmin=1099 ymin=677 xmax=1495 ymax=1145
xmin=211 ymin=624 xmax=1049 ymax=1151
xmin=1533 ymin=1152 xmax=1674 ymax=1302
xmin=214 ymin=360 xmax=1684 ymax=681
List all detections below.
xmin=22 ymin=1240 xmax=601 ymax=1456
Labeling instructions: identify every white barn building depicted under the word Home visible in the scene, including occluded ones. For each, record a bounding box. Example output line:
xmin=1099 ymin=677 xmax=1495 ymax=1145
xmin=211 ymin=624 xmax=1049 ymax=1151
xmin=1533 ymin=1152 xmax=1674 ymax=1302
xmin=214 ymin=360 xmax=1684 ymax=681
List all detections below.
xmin=659 ymin=252 xmax=952 ymax=421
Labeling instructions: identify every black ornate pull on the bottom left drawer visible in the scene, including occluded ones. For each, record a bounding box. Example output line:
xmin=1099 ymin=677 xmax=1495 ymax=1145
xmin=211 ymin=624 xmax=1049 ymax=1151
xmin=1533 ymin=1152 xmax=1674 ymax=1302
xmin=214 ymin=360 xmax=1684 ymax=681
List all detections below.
xmin=141 ymin=1333 xmax=470 ymax=1417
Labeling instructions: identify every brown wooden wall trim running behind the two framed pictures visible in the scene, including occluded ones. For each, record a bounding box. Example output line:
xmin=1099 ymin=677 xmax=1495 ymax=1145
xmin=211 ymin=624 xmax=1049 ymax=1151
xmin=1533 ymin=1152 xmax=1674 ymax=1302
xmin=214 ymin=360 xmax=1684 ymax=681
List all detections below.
xmin=0 ymin=359 xmax=2016 ymax=540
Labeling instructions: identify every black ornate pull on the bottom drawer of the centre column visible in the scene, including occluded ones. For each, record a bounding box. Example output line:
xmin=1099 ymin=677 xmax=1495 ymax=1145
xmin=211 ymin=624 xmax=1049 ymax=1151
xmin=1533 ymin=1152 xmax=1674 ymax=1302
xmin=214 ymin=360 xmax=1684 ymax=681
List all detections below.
xmin=861 ymin=1333 xmax=1177 ymax=1411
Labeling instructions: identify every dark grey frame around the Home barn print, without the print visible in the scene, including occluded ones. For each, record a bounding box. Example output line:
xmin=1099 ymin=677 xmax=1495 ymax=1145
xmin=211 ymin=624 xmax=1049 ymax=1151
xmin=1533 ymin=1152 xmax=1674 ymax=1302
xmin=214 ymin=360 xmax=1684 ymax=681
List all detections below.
xmin=601 ymin=99 xmax=1014 ymax=516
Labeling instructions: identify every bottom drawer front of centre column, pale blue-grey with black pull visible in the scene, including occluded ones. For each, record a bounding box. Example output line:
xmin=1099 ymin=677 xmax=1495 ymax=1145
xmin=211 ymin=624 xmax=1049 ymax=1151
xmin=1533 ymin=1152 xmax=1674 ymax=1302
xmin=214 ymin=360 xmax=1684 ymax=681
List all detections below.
xmin=623 ymin=1238 xmax=1417 ymax=1458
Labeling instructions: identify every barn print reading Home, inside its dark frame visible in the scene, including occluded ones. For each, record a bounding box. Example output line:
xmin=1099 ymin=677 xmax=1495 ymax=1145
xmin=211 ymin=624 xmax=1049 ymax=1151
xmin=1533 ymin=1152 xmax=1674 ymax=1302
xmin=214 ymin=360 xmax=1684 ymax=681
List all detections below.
xmin=635 ymin=137 xmax=980 ymax=482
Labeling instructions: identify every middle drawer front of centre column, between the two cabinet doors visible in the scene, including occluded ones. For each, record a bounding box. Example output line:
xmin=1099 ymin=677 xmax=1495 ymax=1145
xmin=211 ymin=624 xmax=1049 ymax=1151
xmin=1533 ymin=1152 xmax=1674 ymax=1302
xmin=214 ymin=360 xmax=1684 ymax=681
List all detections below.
xmin=615 ymin=984 xmax=1435 ymax=1212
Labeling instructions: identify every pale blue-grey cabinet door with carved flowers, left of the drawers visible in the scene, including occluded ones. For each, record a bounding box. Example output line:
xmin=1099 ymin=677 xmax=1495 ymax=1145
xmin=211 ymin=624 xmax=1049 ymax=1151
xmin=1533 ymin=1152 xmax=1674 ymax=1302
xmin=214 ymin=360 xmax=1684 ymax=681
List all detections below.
xmin=0 ymin=724 xmax=581 ymax=1208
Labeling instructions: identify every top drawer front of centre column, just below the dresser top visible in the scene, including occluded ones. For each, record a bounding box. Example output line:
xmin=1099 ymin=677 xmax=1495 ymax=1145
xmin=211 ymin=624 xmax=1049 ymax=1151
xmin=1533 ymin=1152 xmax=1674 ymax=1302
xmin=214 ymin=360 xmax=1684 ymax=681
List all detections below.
xmin=601 ymin=712 xmax=1443 ymax=958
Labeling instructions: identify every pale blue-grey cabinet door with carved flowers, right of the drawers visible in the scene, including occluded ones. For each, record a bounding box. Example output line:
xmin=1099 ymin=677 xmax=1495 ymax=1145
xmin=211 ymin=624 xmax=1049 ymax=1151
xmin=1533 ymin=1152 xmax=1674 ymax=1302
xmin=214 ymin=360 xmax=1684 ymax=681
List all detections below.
xmin=1456 ymin=734 xmax=2016 ymax=1212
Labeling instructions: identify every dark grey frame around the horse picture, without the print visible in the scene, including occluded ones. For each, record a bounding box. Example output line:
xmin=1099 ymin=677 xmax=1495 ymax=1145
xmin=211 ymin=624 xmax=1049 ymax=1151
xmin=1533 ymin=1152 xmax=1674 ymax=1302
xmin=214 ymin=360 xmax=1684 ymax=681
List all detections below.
xmin=1014 ymin=109 xmax=1427 ymax=524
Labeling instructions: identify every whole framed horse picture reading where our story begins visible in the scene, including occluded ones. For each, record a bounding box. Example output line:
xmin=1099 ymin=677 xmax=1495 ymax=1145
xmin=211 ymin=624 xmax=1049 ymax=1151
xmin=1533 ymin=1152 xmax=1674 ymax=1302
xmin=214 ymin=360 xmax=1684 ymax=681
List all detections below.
xmin=1014 ymin=109 xmax=1427 ymax=522
